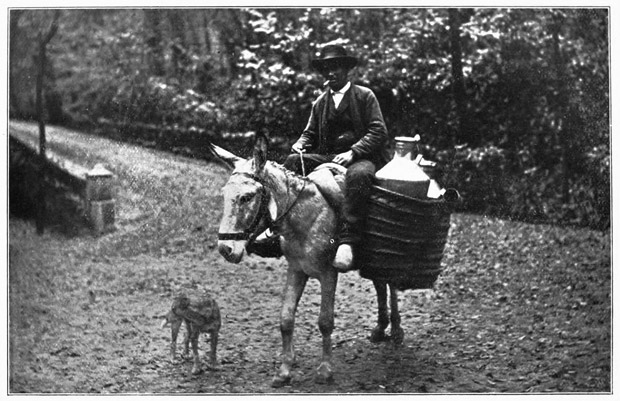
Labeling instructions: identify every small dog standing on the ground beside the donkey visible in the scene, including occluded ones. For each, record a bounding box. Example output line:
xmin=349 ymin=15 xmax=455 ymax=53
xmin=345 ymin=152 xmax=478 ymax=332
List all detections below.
xmin=161 ymin=292 xmax=222 ymax=374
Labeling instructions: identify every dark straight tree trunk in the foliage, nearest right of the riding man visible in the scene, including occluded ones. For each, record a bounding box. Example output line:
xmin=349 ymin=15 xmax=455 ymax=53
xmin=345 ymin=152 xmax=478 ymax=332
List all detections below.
xmin=448 ymin=8 xmax=474 ymax=144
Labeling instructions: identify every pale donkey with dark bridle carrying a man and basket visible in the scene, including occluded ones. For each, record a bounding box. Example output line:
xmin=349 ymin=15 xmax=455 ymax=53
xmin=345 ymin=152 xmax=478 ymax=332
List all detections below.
xmin=210 ymin=136 xmax=402 ymax=387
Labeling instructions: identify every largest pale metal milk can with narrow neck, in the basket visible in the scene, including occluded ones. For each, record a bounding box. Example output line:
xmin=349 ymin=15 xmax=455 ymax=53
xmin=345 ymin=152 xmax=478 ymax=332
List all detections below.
xmin=375 ymin=136 xmax=431 ymax=199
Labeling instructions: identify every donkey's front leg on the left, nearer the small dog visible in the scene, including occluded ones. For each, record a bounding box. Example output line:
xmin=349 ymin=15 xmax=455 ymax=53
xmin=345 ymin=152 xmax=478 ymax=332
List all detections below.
xmin=271 ymin=267 xmax=308 ymax=387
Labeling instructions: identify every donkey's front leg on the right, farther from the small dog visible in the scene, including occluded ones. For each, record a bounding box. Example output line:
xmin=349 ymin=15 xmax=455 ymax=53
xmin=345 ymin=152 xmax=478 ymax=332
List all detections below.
xmin=316 ymin=269 xmax=338 ymax=383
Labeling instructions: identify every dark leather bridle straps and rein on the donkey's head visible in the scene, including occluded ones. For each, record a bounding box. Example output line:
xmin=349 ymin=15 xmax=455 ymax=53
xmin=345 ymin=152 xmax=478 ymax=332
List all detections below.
xmin=218 ymin=172 xmax=306 ymax=245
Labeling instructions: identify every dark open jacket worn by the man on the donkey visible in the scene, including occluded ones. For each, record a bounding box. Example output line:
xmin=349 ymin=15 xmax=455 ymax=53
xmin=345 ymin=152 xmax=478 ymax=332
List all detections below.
xmin=297 ymin=84 xmax=389 ymax=168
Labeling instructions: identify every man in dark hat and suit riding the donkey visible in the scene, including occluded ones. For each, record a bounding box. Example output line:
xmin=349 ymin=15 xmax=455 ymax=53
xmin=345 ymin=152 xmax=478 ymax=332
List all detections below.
xmin=257 ymin=45 xmax=389 ymax=272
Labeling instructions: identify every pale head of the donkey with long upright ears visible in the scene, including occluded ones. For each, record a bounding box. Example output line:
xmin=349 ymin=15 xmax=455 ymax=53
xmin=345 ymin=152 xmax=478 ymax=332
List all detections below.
xmin=211 ymin=137 xmax=270 ymax=263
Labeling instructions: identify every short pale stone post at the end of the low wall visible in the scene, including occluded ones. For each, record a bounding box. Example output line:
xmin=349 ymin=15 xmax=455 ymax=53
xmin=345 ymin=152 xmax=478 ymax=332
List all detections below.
xmin=86 ymin=164 xmax=115 ymax=234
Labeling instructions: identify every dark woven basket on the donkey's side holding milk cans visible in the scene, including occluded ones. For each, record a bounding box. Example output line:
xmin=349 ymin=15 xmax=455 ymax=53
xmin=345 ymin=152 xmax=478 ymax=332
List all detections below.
xmin=357 ymin=186 xmax=452 ymax=290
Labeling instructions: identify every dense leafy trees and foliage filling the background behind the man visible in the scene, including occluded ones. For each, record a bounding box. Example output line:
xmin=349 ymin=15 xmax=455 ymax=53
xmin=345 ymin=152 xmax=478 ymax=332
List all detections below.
xmin=10 ymin=8 xmax=610 ymax=229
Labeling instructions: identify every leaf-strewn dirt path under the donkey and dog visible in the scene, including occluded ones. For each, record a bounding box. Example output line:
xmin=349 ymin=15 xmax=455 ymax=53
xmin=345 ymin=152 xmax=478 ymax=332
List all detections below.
xmin=9 ymin=123 xmax=611 ymax=394
